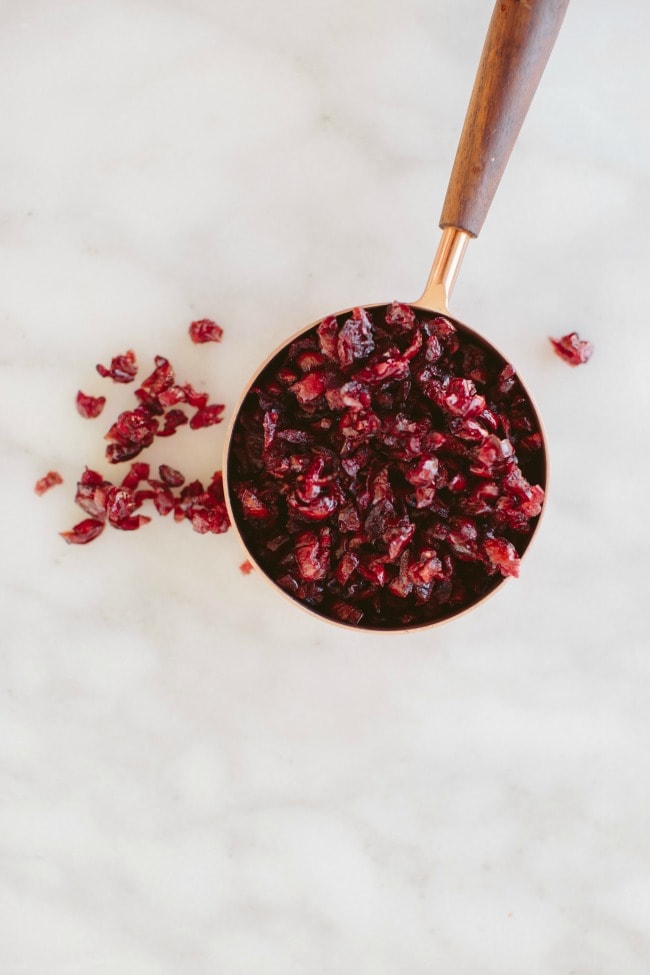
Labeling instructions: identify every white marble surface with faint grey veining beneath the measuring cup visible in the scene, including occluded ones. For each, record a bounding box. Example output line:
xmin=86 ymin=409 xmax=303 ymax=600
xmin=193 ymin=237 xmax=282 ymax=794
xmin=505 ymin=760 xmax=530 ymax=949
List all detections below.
xmin=0 ymin=0 xmax=650 ymax=975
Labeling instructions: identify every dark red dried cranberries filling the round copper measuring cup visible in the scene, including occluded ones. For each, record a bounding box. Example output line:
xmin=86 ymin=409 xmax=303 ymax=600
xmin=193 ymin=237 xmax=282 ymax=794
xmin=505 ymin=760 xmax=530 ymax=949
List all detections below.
xmin=228 ymin=302 xmax=546 ymax=629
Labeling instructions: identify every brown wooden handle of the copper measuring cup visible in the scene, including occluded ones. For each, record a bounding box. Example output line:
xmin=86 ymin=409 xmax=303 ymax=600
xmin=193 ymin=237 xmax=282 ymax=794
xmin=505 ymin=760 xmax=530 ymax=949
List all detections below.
xmin=440 ymin=0 xmax=569 ymax=237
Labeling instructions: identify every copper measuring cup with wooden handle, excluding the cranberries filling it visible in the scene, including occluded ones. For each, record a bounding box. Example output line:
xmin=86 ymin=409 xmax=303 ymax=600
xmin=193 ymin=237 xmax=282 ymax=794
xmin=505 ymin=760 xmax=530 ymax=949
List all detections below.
xmin=223 ymin=0 xmax=569 ymax=632
